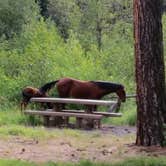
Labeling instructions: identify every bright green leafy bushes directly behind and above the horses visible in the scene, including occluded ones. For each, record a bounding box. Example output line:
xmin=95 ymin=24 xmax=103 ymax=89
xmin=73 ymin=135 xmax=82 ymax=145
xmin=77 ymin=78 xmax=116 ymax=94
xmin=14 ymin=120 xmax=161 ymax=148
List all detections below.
xmin=0 ymin=20 xmax=106 ymax=104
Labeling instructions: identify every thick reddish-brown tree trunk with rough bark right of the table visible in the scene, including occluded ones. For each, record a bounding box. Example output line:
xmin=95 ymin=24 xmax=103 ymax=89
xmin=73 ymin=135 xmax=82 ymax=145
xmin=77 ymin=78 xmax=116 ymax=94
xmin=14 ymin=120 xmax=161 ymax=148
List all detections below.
xmin=134 ymin=0 xmax=166 ymax=146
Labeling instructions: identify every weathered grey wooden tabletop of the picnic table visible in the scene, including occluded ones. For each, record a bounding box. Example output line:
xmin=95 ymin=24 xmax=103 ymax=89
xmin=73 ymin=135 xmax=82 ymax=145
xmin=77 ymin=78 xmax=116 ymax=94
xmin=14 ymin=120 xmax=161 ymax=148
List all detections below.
xmin=30 ymin=97 xmax=117 ymax=106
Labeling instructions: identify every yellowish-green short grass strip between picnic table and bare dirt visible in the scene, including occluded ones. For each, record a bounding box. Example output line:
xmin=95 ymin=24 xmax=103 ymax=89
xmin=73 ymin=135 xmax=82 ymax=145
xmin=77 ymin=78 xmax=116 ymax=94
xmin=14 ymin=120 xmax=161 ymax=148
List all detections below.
xmin=0 ymin=125 xmax=96 ymax=140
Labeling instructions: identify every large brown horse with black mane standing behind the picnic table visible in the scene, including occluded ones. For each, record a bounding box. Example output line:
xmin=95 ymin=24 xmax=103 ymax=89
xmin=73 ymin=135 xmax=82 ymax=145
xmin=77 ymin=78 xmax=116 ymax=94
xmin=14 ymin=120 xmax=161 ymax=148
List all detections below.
xmin=52 ymin=78 xmax=126 ymax=111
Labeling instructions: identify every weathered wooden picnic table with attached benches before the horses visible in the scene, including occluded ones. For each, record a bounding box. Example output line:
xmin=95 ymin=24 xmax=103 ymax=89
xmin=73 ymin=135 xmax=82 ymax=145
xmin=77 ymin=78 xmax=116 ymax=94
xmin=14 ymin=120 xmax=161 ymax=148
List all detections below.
xmin=24 ymin=98 xmax=121 ymax=128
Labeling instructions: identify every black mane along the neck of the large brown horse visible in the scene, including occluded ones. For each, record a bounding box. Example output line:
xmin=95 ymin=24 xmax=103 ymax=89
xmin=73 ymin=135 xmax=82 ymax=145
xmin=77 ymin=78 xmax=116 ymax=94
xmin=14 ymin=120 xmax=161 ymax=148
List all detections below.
xmin=90 ymin=81 xmax=124 ymax=91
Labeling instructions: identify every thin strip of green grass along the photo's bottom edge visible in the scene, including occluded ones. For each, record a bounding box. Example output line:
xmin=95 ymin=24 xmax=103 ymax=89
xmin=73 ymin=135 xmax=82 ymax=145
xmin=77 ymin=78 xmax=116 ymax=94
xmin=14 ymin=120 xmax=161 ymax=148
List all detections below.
xmin=0 ymin=157 xmax=166 ymax=166
